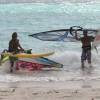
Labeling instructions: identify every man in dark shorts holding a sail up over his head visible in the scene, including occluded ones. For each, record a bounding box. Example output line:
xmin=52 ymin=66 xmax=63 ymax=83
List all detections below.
xmin=75 ymin=30 xmax=94 ymax=68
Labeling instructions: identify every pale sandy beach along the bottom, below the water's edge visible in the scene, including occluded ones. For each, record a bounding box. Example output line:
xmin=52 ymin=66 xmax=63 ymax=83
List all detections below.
xmin=0 ymin=81 xmax=100 ymax=100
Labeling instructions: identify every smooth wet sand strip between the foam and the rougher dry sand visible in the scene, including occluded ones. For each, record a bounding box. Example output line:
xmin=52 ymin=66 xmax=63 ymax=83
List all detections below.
xmin=0 ymin=79 xmax=100 ymax=89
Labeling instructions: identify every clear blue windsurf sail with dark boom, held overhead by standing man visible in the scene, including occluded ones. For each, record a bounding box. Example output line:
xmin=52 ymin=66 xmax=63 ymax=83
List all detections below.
xmin=29 ymin=26 xmax=97 ymax=41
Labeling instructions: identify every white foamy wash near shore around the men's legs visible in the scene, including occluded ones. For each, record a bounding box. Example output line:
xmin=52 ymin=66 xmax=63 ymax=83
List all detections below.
xmin=0 ymin=51 xmax=100 ymax=82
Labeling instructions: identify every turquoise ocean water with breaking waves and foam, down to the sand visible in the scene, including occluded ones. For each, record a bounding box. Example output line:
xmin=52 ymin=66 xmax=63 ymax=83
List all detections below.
xmin=0 ymin=0 xmax=100 ymax=82
